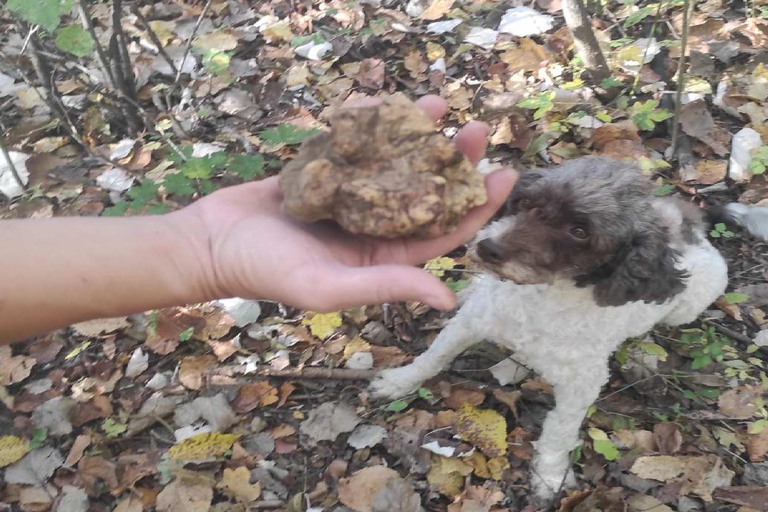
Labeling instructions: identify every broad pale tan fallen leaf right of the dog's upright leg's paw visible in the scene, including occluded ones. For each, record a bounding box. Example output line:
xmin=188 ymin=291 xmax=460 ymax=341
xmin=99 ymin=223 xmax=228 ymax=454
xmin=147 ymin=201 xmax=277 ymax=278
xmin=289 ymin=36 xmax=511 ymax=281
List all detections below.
xmin=630 ymin=454 xmax=735 ymax=503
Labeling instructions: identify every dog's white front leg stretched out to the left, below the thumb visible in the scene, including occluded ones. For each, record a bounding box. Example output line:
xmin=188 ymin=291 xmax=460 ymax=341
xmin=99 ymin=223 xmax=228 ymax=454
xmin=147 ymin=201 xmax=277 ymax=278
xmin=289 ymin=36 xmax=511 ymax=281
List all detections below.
xmin=369 ymin=310 xmax=478 ymax=398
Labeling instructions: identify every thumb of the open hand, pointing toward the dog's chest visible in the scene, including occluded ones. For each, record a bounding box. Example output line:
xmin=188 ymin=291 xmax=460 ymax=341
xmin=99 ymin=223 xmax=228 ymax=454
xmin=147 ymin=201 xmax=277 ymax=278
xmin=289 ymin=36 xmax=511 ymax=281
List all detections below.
xmin=320 ymin=265 xmax=456 ymax=310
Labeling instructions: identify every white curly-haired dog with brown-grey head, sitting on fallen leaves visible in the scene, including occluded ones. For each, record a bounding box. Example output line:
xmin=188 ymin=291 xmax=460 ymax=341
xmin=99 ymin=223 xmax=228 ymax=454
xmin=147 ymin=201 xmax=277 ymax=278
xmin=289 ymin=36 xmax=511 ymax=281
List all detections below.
xmin=370 ymin=156 xmax=752 ymax=501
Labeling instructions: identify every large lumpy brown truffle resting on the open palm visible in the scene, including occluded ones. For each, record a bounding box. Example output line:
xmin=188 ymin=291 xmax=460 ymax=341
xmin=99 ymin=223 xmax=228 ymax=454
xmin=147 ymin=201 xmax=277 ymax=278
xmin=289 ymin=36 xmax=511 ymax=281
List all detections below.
xmin=280 ymin=96 xmax=486 ymax=238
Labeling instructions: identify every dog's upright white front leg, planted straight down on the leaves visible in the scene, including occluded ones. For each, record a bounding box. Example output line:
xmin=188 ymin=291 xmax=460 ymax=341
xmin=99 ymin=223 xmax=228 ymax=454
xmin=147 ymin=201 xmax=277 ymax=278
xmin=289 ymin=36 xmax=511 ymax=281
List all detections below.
xmin=531 ymin=364 xmax=608 ymax=500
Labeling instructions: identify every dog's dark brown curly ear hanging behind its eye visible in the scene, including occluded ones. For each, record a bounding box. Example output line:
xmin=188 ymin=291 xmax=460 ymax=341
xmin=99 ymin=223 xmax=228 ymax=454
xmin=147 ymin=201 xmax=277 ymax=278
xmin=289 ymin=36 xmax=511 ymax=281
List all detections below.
xmin=577 ymin=226 xmax=688 ymax=306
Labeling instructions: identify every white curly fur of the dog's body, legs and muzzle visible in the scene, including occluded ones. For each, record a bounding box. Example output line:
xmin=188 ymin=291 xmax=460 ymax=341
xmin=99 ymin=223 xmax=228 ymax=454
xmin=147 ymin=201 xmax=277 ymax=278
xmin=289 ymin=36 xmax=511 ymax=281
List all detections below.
xmin=371 ymin=200 xmax=727 ymax=499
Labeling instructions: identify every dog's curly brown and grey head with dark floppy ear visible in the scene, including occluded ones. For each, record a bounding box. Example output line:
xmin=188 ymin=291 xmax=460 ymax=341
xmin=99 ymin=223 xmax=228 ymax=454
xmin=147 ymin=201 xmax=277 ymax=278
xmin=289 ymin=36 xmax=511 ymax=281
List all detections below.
xmin=470 ymin=157 xmax=686 ymax=306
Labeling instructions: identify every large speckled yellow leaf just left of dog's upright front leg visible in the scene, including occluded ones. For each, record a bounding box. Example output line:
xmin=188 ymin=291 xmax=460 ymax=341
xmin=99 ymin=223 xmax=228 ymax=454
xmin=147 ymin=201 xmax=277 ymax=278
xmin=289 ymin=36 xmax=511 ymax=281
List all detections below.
xmin=454 ymin=404 xmax=507 ymax=457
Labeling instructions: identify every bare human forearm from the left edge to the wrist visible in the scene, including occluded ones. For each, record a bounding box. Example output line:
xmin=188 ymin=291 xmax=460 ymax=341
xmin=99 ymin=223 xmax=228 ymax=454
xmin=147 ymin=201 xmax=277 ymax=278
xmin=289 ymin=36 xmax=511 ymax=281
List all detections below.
xmin=0 ymin=214 xmax=215 ymax=343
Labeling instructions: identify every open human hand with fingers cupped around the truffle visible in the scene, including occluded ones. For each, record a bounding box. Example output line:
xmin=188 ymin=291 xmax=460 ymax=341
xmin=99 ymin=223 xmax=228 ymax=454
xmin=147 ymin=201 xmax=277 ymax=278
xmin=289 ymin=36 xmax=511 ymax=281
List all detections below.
xmin=179 ymin=96 xmax=516 ymax=312
